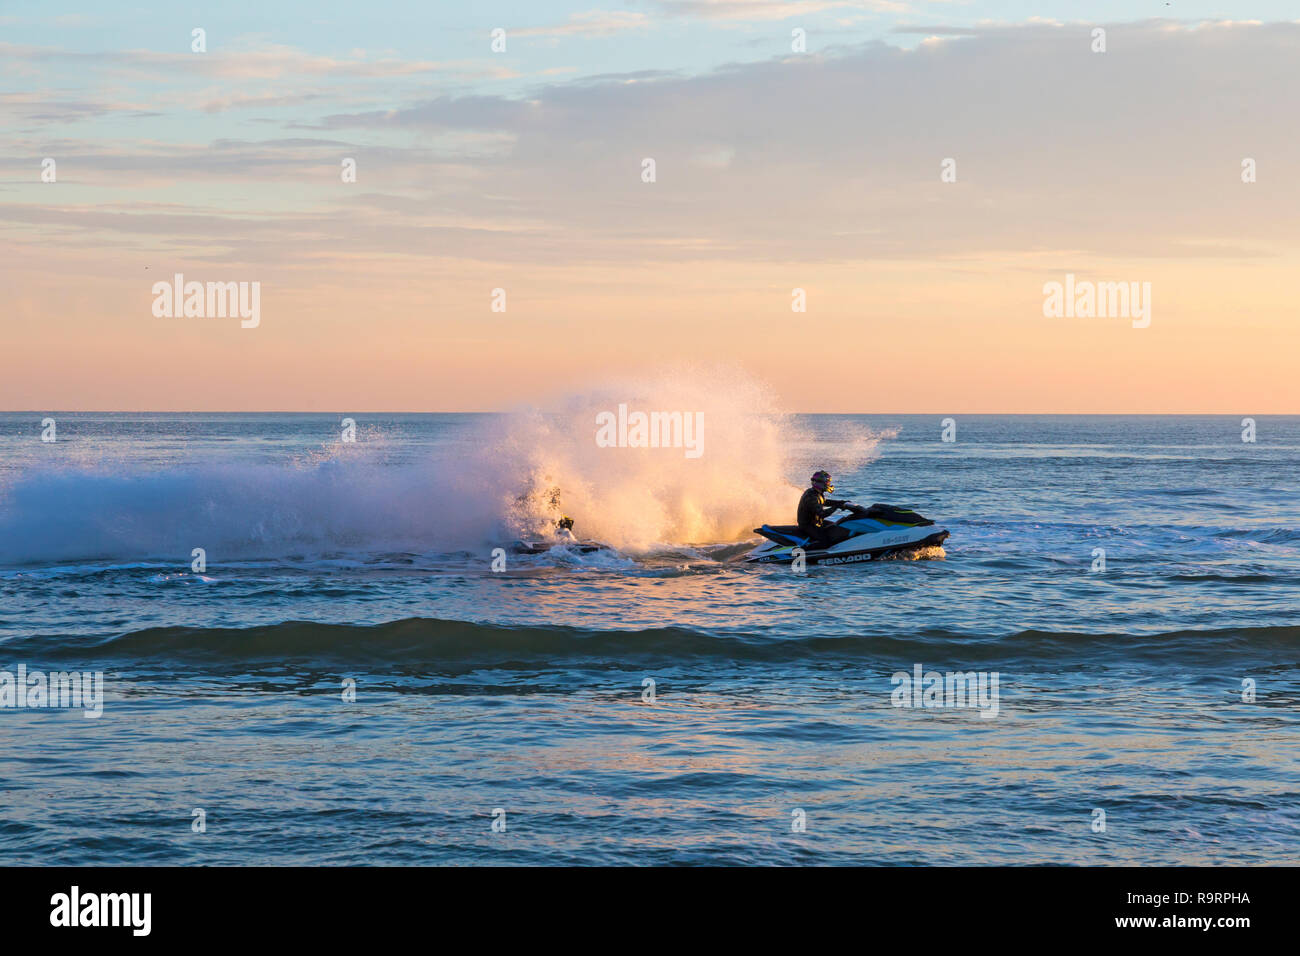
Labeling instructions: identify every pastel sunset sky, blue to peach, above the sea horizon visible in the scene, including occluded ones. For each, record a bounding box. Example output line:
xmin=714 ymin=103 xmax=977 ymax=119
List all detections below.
xmin=0 ymin=0 xmax=1300 ymax=415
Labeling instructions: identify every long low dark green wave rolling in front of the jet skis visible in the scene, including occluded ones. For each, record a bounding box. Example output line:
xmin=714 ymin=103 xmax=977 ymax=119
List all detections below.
xmin=10 ymin=618 xmax=1300 ymax=671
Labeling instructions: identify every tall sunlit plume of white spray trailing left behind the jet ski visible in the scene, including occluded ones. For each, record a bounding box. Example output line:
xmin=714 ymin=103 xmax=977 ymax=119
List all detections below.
xmin=0 ymin=367 xmax=878 ymax=566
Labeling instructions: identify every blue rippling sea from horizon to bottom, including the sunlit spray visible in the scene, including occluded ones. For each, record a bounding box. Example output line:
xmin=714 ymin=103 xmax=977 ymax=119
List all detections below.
xmin=0 ymin=411 xmax=1300 ymax=865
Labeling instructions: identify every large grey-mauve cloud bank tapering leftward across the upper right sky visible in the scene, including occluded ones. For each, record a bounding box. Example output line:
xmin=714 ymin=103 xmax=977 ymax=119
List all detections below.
xmin=287 ymin=22 xmax=1300 ymax=259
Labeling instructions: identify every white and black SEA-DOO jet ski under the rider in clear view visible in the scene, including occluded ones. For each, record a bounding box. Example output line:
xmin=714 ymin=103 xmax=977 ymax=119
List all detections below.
xmin=745 ymin=505 xmax=948 ymax=564
